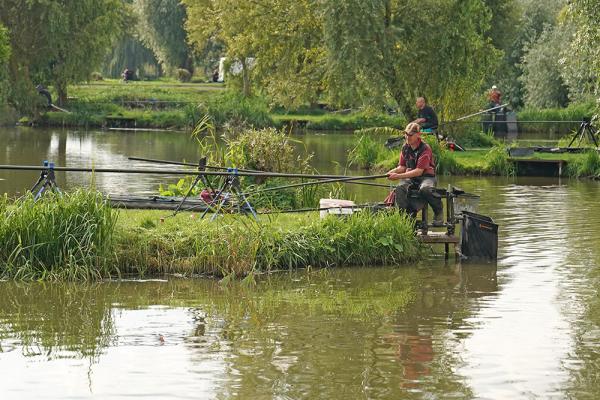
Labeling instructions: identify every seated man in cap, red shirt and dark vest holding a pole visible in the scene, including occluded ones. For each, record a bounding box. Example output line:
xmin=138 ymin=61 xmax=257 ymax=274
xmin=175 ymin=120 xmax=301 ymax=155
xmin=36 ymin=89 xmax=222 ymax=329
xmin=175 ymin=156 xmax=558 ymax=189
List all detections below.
xmin=387 ymin=122 xmax=444 ymax=226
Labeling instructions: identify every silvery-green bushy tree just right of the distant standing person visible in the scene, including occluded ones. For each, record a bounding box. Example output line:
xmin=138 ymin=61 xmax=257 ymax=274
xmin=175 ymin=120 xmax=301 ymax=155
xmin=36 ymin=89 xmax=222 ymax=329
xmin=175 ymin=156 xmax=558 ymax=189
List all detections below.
xmin=520 ymin=26 xmax=571 ymax=108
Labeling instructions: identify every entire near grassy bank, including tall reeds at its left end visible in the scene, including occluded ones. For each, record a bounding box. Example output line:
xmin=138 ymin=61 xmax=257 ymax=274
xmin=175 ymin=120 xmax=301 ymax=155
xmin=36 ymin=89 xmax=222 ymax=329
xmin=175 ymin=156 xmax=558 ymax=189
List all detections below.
xmin=0 ymin=192 xmax=422 ymax=280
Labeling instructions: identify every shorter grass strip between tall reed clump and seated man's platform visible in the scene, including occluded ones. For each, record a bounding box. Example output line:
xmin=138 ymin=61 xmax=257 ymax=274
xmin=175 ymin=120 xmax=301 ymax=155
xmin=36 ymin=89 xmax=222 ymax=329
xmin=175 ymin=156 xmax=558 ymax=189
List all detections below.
xmin=117 ymin=212 xmax=421 ymax=276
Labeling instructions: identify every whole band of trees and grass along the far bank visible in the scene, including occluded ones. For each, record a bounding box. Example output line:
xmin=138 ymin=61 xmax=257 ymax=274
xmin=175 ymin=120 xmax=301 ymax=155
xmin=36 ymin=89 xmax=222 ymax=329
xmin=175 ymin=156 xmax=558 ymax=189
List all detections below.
xmin=0 ymin=0 xmax=598 ymax=134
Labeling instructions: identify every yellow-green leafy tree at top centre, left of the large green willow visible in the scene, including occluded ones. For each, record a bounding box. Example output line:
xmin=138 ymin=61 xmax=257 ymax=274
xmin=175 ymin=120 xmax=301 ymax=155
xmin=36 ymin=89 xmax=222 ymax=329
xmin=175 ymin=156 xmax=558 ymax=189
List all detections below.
xmin=183 ymin=0 xmax=325 ymax=107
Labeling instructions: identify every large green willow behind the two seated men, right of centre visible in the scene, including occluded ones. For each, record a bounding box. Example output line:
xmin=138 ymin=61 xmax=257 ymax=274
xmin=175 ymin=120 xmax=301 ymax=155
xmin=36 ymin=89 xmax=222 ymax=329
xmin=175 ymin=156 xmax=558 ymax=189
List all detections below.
xmin=324 ymin=0 xmax=500 ymax=117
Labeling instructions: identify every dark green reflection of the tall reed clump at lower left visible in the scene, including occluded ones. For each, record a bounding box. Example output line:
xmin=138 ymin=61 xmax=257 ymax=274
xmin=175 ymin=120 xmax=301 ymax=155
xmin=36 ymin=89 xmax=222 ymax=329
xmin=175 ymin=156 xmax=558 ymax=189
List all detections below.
xmin=0 ymin=283 xmax=113 ymax=358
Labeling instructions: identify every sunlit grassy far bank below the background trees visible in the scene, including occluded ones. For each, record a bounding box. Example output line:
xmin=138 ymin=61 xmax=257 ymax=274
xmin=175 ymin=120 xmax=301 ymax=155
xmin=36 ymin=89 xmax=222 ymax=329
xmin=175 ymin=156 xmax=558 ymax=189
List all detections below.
xmin=37 ymin=80 xmax=405 ymax=130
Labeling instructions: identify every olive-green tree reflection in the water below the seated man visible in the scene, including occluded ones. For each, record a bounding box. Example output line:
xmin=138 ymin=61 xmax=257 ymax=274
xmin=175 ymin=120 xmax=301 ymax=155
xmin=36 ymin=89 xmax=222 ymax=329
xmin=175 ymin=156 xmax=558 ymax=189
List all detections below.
xmin=185 ymin=267 xmax=496 ymax=399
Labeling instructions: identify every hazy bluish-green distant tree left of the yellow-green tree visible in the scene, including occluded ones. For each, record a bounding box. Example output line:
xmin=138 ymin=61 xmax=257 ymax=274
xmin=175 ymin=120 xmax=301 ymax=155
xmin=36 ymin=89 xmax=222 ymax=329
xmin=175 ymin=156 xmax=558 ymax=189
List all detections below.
xmin=133 ymin=0 xmax=194 ymax=73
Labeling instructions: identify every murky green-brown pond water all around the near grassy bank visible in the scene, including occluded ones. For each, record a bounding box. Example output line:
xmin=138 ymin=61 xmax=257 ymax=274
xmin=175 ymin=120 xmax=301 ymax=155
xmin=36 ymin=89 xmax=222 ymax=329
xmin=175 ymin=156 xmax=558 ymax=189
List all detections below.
xmin=0 ymin=129 xmax=600 ymax=399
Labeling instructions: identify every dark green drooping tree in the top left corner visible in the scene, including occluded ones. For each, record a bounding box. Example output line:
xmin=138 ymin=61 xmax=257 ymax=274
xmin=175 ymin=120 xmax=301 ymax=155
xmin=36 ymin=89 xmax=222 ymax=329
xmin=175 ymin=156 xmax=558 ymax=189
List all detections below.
xmin=0 ymin=0 xmax=127 ymax=111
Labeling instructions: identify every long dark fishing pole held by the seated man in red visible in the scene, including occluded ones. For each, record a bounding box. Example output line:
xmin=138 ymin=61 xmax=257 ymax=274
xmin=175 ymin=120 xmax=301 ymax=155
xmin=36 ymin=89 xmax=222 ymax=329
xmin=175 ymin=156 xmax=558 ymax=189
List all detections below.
xmin=0 ymin=165 xmax=385 ymax=180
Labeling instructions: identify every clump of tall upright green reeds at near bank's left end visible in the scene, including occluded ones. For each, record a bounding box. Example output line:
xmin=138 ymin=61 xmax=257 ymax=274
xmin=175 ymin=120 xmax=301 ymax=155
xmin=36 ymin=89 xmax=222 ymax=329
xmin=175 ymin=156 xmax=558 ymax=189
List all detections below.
xmin=0 ymin=191 xmax=118 ymax=280
